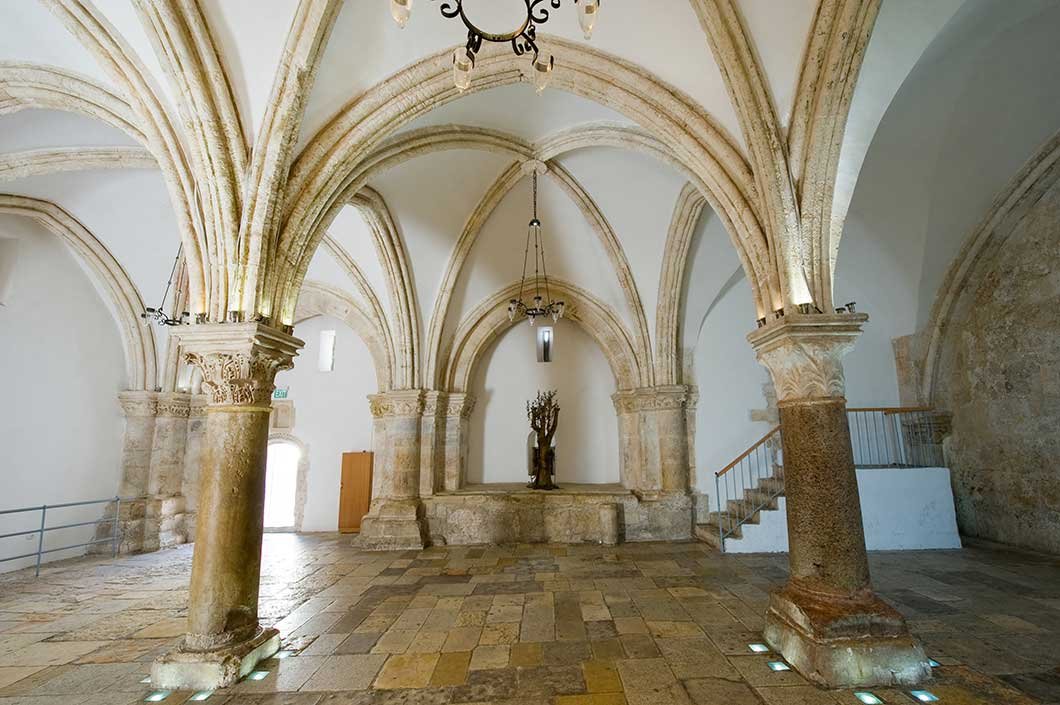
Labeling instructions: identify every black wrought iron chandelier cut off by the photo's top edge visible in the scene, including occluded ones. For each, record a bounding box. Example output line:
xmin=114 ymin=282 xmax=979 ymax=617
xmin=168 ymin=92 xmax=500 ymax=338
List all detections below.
xmin=390 ymin=0 xmax=601 ymax=93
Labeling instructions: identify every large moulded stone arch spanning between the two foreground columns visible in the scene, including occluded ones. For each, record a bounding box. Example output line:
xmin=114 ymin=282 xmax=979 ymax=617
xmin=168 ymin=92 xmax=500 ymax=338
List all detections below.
xmin=265 ymin=38 xmax=778 ymax=316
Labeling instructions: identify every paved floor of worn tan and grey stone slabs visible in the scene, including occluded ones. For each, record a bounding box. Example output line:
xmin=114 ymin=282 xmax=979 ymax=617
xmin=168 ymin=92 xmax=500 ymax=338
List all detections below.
xmin=0 ymin=534 xmax=1060 ymax=705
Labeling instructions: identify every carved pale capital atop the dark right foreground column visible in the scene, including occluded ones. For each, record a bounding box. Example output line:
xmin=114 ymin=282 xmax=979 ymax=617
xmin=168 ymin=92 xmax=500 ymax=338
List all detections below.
xmin=747 ymin=314 xmax=868 ymax=402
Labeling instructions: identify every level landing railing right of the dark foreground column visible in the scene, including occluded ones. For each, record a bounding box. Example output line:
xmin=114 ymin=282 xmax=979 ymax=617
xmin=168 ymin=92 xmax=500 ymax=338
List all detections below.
xmin=847 ymin=407 xmax=948 ymax=468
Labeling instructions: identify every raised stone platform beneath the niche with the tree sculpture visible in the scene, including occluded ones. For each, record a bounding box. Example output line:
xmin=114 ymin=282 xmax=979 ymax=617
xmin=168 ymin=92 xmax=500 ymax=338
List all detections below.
xmin=423 ymin=482 xmax=692 ymax=545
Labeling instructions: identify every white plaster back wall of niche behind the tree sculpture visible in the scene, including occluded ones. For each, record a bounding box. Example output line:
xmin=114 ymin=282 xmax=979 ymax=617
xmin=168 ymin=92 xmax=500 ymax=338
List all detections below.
xmin=467 ymin=320 xmax=619 ymax=486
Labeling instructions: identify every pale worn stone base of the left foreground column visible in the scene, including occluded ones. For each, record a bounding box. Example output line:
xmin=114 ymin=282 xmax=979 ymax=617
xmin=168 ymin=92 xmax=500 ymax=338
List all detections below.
xmin=151 ymin=629 xmax=280 ymax=690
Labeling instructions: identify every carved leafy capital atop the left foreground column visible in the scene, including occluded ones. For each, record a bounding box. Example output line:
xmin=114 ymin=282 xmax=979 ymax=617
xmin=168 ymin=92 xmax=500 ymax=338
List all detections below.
xmin=173 ymin=323 xmax=303 ymax=409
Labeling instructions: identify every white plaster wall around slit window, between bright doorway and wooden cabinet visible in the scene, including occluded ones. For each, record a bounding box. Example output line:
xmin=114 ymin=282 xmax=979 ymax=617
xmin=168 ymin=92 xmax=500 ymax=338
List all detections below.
xmin=276 ymin=316 xmax=378 ymax=531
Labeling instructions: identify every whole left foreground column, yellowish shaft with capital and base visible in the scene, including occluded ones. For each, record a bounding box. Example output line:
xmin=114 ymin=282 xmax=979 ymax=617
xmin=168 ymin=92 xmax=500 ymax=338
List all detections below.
xmin=152 ymin=323 xmax=302 ymax=690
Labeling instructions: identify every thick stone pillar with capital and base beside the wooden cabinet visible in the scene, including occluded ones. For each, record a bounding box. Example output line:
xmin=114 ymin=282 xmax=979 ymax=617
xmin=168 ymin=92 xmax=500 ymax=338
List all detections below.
xmin=357 ymin=389 xmax=427 ymax=550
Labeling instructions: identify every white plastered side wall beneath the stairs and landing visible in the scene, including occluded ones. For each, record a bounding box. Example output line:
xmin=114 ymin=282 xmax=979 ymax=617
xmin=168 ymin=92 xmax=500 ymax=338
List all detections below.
xmin=725 ymin=468 xmax=960 ymax=553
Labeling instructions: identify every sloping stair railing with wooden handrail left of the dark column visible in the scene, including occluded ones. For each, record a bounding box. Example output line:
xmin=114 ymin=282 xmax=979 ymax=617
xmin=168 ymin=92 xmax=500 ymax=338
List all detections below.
xmin=714 ymin=426 xmax=784 ymax=551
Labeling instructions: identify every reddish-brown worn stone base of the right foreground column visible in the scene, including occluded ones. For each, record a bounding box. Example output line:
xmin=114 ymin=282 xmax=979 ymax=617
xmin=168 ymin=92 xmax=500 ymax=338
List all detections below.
xmin=764 ymin=585 xmax=931 ymax=688
